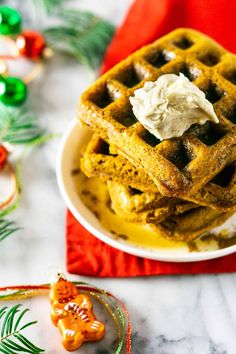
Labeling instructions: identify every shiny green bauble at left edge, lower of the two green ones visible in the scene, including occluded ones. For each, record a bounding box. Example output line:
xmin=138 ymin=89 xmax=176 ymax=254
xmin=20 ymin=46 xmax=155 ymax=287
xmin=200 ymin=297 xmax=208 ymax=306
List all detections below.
xmin=0 ymin=76 xmax=27 ymax=106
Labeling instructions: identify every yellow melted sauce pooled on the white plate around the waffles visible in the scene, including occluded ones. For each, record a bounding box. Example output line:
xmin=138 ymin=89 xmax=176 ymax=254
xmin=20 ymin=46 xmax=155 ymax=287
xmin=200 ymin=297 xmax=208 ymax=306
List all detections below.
xmin=71 ymin=168 xmax=236 ymax=252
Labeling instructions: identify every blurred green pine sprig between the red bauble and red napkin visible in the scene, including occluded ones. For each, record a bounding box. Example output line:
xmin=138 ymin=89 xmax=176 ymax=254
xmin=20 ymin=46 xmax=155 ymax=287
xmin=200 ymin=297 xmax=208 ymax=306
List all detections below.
xmin=44 ymin=9 xmax=114 ymax=69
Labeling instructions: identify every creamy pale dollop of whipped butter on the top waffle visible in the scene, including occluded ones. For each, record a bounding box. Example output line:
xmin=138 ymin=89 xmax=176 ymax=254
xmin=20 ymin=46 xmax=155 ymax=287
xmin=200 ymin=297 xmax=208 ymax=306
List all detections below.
xmin=130 ymin=73 xmax=219 ymax=140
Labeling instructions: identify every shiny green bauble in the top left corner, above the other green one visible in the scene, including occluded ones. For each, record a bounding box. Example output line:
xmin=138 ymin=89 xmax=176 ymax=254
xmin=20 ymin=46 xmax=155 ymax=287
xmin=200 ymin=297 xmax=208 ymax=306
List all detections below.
xmin=0 ymin=6 xmax=21 ymax=35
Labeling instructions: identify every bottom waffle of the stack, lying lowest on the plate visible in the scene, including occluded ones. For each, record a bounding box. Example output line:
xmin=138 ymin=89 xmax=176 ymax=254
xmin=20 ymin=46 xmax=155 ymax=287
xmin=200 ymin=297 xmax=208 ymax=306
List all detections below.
xmin=152 ymin=207 xmax=233 ymax=241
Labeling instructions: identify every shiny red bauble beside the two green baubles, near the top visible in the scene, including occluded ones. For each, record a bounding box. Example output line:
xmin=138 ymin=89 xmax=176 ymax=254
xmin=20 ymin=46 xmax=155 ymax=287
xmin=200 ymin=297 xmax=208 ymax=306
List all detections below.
xmin=16 ymin=30 xmax=45 ymax=59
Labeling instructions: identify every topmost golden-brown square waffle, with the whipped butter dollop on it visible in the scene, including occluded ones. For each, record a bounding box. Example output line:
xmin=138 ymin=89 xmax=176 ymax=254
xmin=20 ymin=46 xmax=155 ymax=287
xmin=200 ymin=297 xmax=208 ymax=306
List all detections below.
xmin=78 ymin=29 xmax=236 ymax=199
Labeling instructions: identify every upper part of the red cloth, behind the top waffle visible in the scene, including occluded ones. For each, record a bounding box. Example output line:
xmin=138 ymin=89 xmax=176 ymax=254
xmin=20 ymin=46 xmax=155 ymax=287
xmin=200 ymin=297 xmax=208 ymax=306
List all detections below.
xmin=102 ymin=0 xmax=236 ymax=72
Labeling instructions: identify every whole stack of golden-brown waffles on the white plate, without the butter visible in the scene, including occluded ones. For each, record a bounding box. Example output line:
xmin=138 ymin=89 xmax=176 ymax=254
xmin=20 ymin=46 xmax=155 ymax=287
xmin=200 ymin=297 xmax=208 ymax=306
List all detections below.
xmin=78 ymin=29 xmax=236 ymax=241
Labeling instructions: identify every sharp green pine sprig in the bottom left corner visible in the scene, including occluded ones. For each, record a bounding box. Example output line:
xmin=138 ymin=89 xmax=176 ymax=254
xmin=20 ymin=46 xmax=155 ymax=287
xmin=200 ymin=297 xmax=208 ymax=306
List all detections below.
xmin=0 ymin=305 xmax=44 ymax=354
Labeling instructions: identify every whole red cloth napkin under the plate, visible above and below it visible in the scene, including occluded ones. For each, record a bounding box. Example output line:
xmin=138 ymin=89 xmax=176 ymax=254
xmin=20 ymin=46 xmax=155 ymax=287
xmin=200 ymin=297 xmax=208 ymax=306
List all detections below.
xmin=66 ymin=0 xmax=236 ymax=277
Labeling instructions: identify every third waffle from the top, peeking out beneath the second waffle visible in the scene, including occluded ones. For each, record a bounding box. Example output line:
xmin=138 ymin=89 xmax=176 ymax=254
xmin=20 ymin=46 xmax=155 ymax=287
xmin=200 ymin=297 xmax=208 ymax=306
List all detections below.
xmin=108 ymin=181 xmax=199 ymax=224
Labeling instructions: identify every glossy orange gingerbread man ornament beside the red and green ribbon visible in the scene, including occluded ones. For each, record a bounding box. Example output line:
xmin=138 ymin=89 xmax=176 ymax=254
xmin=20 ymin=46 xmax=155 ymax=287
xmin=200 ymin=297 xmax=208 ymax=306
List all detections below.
xmin=50 ymin=277 xmax=105 ymax=351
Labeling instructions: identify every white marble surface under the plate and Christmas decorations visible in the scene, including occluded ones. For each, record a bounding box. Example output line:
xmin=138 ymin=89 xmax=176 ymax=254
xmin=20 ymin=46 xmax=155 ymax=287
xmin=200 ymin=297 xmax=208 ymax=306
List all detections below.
xmin=0 ymin=0 xmax=236 ymax=354
